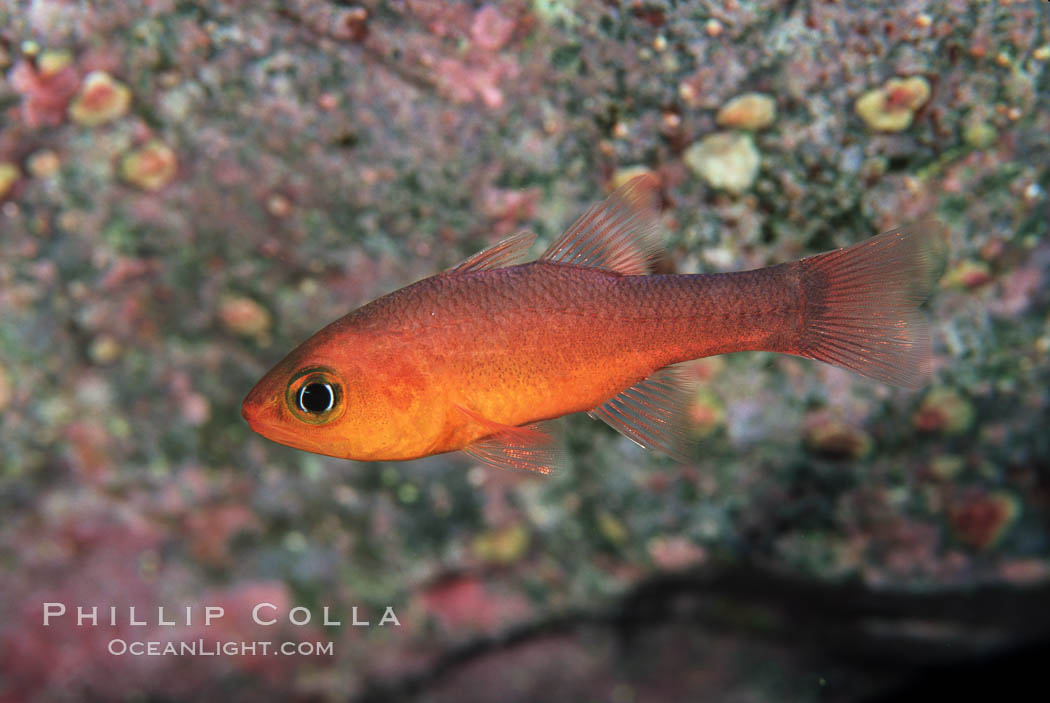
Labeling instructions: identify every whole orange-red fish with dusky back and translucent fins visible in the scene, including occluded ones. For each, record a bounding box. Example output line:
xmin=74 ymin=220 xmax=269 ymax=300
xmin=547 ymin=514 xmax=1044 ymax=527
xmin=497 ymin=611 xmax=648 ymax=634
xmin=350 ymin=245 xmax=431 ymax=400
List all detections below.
xmin=242 ymin=176 xmax=946 ymax=473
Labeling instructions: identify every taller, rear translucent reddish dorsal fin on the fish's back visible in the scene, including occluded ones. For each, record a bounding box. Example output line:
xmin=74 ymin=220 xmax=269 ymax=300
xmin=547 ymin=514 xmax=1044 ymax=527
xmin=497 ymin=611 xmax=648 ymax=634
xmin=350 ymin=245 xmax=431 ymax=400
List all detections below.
xmin=540 ymin=174 xmax=660 ymax=276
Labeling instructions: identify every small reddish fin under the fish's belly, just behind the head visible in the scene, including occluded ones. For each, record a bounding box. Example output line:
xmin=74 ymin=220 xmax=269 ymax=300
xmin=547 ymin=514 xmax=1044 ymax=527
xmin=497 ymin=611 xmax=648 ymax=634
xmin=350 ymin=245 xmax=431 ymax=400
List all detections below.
xmin=456 ymin=405 xmax=565 ymax=474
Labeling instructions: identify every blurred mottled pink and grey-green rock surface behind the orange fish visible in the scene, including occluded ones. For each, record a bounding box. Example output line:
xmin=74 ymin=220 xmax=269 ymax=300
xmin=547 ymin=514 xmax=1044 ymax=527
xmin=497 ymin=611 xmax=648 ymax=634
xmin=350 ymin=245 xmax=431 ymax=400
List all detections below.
xmin=0 ymin=0 xmax=1050 ymax=703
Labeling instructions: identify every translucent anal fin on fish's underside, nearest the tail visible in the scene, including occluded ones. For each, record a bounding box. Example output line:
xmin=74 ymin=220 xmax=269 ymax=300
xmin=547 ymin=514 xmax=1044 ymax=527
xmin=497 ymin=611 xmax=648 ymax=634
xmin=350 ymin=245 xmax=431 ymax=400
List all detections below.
xmin=587 ymin=366 xmax=692 ymax=462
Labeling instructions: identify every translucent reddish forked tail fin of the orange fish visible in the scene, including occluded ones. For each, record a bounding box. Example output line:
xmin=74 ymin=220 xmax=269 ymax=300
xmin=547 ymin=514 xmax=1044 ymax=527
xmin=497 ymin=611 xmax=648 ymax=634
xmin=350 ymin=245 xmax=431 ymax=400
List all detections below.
xmin=798 ymin=219 xmax=947 ymax=388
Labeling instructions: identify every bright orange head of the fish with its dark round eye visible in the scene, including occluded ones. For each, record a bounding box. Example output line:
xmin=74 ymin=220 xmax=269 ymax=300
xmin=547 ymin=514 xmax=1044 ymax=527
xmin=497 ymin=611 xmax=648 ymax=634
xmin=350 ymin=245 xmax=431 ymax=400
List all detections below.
xmin=240 ymin=318 xmax=433 ymax=461
